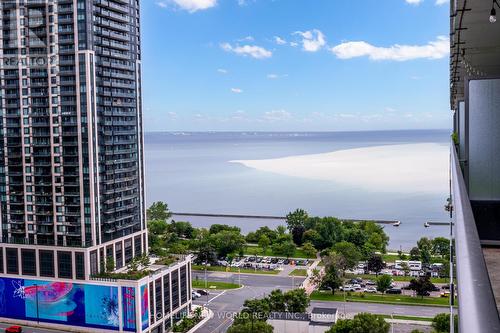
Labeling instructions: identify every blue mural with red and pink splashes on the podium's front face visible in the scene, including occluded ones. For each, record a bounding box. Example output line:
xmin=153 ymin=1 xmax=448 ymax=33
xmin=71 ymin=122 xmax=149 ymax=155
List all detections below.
xmin=0 ymin=278 xmax=135 ymax=330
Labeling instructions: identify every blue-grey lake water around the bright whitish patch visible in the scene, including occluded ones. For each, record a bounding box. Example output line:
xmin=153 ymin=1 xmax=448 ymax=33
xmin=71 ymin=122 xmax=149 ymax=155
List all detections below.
xmin=145 ymin=130 xmax=449 ymax=249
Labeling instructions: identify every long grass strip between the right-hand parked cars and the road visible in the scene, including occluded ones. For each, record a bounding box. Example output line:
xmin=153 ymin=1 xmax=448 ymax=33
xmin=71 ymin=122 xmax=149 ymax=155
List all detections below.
xmin=311 ymin=291 xmax=450 ymax=306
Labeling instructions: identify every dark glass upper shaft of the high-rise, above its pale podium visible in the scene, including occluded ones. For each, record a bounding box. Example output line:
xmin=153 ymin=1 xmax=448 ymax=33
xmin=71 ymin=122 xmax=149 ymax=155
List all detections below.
xmin=0 ymin=0 xmax=145 ymax=270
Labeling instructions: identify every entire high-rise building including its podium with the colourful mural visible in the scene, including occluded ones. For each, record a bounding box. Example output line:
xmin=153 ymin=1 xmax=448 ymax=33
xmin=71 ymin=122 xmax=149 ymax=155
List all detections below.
xmin=0 ymin=0 xmax=191 ymax=332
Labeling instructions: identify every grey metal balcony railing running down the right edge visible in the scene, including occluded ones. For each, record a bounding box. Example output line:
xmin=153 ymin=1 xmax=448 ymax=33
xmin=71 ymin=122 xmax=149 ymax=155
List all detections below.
xmin=451 ymin=144 xmax=500 ymax=333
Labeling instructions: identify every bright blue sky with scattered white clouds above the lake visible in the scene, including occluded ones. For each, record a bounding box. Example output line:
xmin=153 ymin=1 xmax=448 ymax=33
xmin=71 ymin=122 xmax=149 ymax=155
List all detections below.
xmin=142 ymin=0 xmax=451 ymax=131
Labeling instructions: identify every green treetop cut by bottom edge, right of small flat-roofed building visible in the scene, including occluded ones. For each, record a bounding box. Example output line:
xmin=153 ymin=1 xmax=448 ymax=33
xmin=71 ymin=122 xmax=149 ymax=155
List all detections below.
xmin=327 ymin=313 xmax=391 ymax=333
